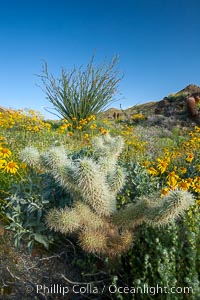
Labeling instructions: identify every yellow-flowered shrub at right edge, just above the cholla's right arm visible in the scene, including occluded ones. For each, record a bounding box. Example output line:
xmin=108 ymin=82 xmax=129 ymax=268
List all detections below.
xmin=143 ymin=126 xmax=200 ymax=196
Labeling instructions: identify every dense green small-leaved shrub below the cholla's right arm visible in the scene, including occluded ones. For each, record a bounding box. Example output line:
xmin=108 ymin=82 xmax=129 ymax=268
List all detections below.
xmin=116 ymin=205 xmax=200 ymax=300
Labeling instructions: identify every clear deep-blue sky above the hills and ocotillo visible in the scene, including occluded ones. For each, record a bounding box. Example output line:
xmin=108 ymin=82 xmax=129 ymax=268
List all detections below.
xmin=0 ymin=0 xmax=200 ymax=119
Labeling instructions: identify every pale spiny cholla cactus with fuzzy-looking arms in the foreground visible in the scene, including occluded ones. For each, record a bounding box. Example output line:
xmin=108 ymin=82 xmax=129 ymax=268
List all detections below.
xmin=20 ymin=135 xmax=194 ymax=256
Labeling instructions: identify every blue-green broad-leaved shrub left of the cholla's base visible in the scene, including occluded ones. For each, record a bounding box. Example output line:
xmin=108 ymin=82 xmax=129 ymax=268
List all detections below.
xmin=2 ymin=172 xmax=71 ymax=252
